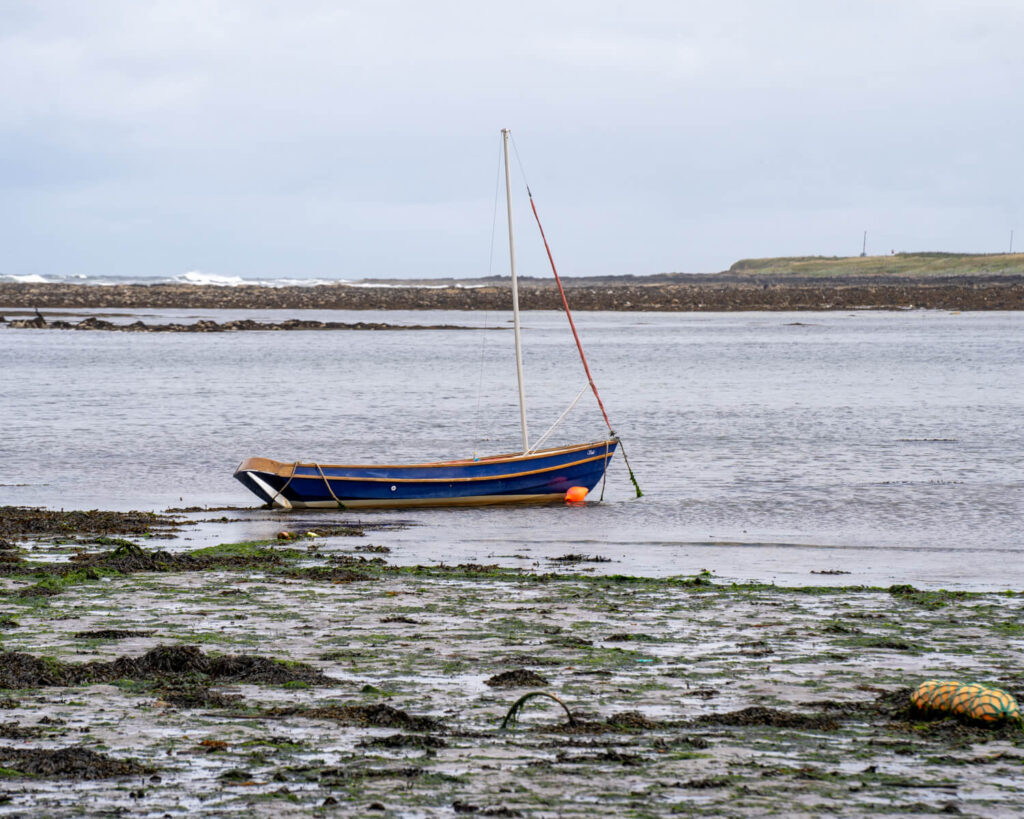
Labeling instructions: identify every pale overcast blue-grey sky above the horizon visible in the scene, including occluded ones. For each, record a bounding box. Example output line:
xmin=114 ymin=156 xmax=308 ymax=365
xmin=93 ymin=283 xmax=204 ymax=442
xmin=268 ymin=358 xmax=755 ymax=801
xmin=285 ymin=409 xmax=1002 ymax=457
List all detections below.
xmin=0 ymin=0 xmax=1024 ymax=278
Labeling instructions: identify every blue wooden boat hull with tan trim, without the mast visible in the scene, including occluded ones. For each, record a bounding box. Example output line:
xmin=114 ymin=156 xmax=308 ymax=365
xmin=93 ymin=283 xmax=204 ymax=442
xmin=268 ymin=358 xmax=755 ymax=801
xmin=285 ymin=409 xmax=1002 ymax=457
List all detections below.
xmin=234 ymin=439 xmax=618 ymax=509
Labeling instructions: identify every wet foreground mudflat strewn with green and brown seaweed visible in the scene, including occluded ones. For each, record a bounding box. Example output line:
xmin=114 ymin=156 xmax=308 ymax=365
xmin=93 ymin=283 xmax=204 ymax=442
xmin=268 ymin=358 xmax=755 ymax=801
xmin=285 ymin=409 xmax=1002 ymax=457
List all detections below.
xmin=0 ymin=508 xmax=1024 ymax=817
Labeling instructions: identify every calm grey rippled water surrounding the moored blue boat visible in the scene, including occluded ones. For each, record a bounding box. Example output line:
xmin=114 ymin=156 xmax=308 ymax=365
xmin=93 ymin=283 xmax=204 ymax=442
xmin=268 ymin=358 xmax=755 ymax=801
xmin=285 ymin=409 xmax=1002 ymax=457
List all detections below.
xmin=0 ymin=310 xmax=1024 ymax=589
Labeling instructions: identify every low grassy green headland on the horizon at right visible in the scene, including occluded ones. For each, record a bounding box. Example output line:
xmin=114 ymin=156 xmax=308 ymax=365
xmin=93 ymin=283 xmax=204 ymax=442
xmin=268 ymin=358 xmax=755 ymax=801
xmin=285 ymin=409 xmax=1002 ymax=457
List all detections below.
xmin=729 ymin=253 xmax=1024 ymax=278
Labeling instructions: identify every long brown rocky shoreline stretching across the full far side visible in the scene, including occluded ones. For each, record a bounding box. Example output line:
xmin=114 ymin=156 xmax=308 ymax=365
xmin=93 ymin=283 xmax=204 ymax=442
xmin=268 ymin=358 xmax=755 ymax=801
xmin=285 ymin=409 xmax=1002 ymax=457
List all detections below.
xmin=0 ymin=276 xmax=1024 ymax=312
